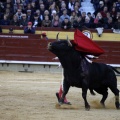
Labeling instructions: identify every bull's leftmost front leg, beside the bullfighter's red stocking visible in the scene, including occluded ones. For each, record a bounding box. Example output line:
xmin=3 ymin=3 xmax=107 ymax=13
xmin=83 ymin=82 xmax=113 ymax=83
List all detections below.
xmin=59 ymin=80 xmax=70 ymax=104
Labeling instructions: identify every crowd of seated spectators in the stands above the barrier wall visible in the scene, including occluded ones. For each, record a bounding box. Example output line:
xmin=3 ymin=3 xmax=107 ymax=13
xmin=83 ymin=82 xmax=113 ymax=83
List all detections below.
xmin=0 ymin=0 xmax=120 ymax=33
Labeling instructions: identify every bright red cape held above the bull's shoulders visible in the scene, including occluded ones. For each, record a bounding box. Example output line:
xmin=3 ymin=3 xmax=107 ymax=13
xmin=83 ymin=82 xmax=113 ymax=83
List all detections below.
xmin=72 ymin=29 xmax=104 ymax=56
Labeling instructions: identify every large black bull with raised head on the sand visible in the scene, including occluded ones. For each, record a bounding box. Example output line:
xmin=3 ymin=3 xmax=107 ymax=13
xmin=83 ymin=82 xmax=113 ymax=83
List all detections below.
xmin=48 ymin=40 xmax=120 ymax=110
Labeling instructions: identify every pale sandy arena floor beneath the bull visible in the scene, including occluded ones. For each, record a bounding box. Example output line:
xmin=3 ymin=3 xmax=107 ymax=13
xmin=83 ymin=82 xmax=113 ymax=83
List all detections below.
xmin=0 ymin=71 xmax=120 ymax=120
